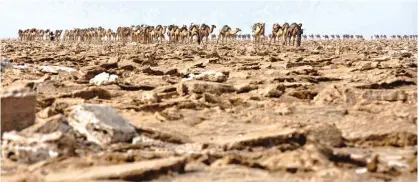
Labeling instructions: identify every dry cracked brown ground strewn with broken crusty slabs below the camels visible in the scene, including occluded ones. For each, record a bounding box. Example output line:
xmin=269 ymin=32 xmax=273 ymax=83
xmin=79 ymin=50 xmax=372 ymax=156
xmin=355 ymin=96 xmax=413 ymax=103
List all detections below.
xmin=1 ymin=40 xmax=418 ymax=182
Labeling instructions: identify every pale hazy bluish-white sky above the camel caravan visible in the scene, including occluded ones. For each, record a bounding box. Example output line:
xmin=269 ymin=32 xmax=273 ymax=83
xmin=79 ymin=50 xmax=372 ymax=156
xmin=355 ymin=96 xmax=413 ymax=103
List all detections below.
xmin=0 ymin=0 xmax=418 ymax=38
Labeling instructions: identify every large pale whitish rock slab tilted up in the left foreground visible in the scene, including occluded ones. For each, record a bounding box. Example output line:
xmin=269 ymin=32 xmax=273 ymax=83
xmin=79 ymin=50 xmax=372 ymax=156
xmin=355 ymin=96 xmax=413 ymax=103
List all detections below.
xmin=68 ymin=104 xmax=136 ymax=146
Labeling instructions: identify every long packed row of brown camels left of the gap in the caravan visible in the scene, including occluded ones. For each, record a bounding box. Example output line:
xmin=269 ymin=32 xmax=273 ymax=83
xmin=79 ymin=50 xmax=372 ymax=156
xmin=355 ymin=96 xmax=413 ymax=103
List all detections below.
xmin=18 ymin=24 xmax=241 ymax=43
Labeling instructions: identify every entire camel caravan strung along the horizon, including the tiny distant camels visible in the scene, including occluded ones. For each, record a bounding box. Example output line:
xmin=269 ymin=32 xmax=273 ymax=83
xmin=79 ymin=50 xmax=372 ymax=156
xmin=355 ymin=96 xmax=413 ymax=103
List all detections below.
xmin=18 ymin=22 xmax=418 ymax=45
